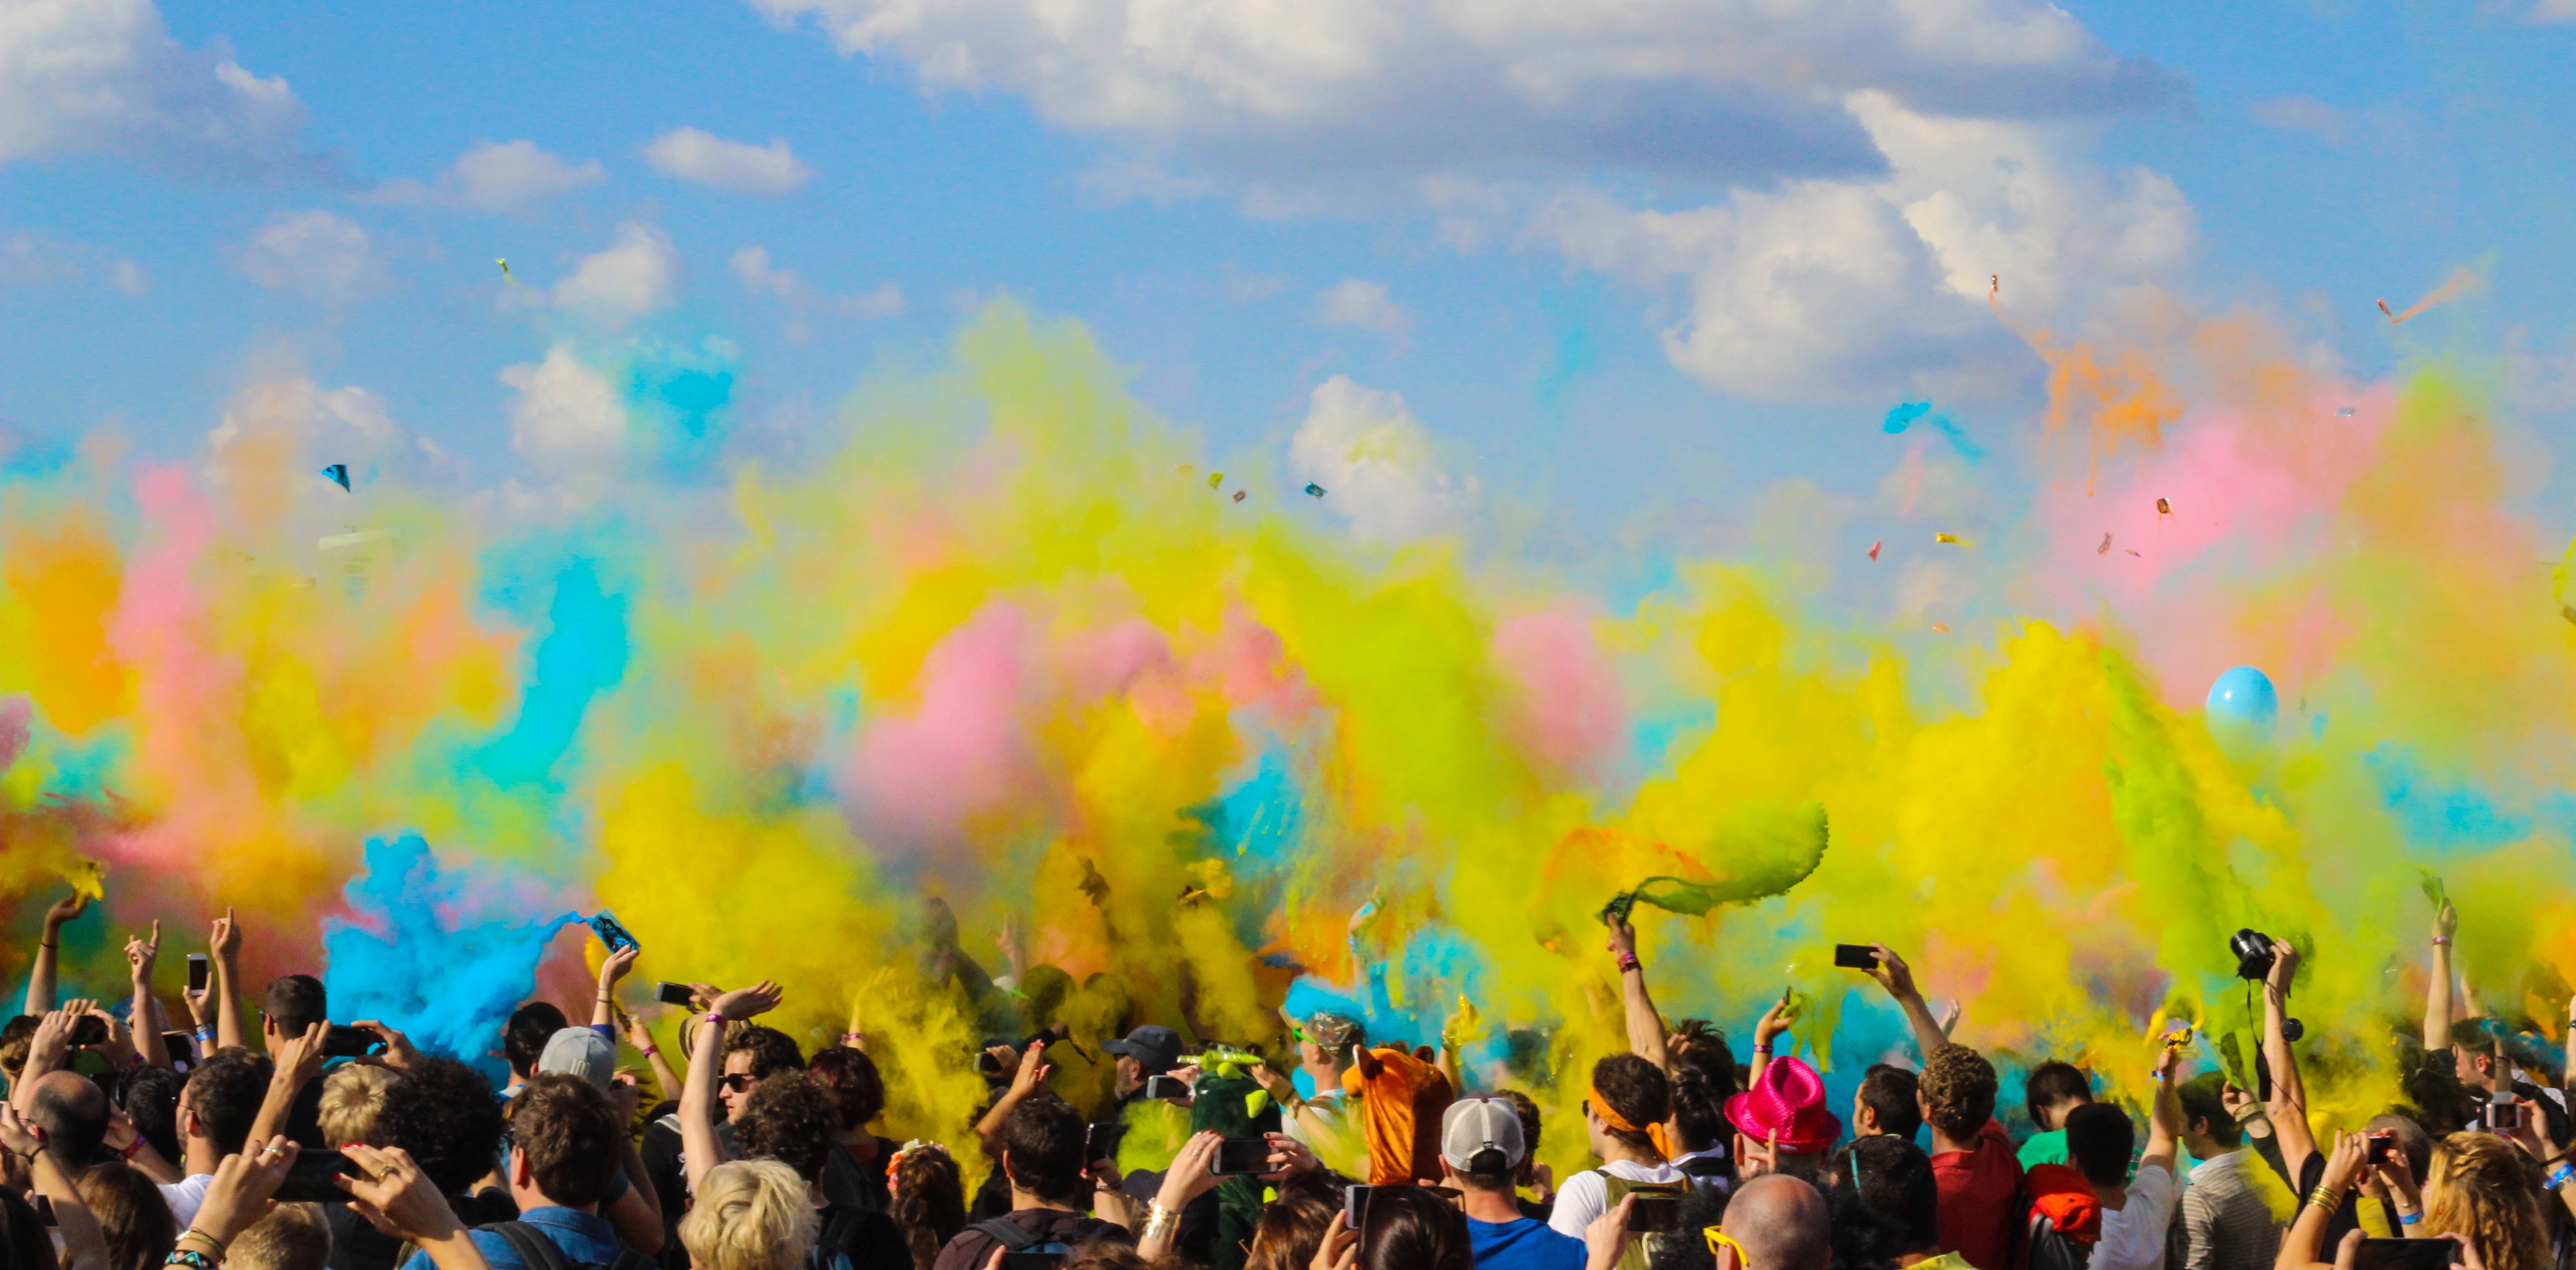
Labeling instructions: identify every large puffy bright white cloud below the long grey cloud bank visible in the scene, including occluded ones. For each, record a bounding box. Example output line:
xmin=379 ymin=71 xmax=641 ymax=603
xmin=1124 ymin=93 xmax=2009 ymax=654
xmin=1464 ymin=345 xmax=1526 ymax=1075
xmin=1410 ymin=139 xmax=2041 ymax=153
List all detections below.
xmin=1532 ymin=93 xmax=2195 ymax=399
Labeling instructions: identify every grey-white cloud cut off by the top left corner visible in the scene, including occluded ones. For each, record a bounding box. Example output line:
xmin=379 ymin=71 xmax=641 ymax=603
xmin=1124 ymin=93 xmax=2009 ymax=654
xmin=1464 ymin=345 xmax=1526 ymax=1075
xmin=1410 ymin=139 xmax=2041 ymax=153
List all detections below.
xmin=0 ymin=0 xmax=330 ymax=178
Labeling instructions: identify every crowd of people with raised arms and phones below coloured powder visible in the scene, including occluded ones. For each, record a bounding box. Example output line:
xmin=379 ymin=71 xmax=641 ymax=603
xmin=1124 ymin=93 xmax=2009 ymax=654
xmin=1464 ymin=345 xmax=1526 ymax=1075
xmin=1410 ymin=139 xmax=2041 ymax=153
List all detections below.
xmin=0 ymin=899 xmax=2576 ymax=1270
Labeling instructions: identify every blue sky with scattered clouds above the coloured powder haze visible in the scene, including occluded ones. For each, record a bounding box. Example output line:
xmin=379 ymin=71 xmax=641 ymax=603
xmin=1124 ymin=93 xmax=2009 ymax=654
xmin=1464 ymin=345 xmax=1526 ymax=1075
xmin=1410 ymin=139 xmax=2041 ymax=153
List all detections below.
xmin=0 ymin=0 xmax=2576 ymax=536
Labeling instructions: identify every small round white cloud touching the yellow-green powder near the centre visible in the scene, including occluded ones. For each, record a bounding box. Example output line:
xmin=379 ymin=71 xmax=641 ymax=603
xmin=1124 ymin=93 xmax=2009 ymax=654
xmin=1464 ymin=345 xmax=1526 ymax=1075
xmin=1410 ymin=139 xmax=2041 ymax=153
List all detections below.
xmin=1288 ymin=376 xmax=1476 ymax=541
